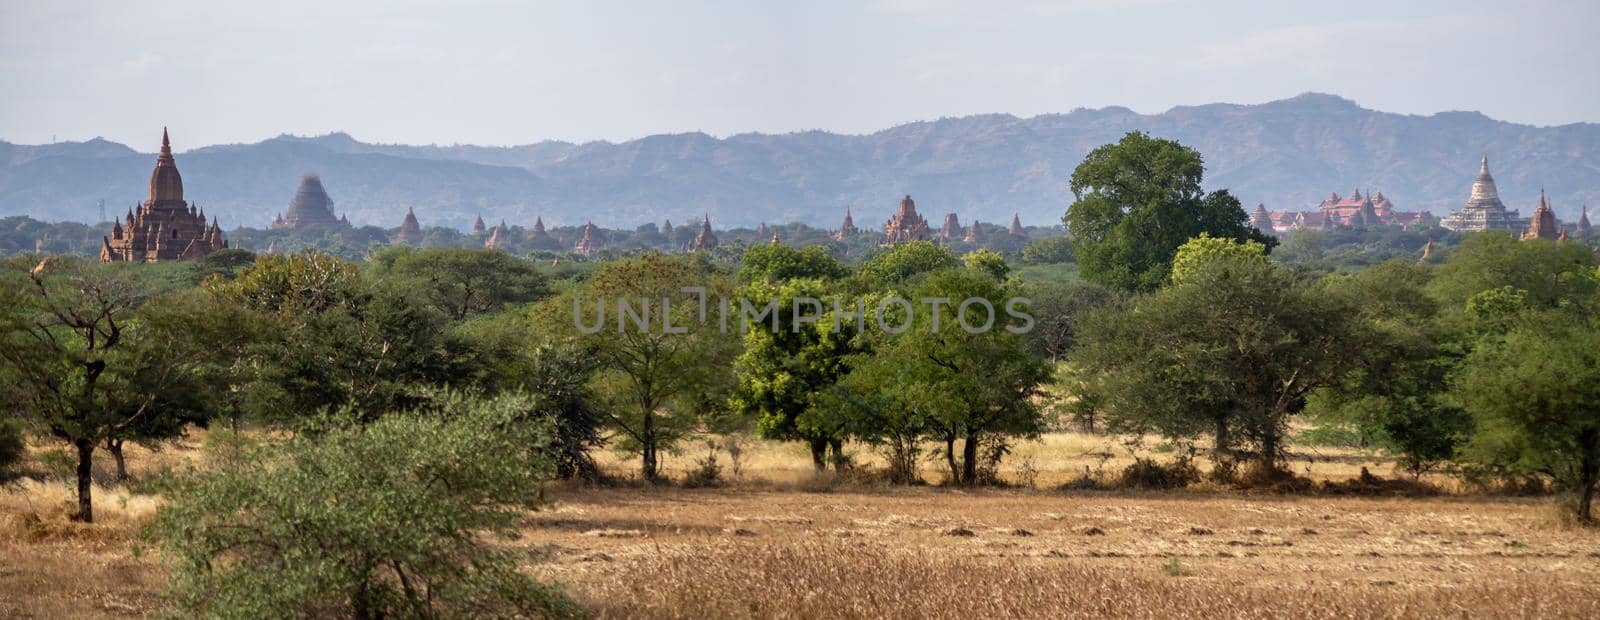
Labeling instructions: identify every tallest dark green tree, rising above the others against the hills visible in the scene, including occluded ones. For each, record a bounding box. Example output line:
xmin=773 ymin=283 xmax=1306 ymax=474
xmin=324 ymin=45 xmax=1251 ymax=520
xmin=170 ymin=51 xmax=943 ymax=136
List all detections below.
xmin=1062 ymin=131 xmax=1277 ymax=291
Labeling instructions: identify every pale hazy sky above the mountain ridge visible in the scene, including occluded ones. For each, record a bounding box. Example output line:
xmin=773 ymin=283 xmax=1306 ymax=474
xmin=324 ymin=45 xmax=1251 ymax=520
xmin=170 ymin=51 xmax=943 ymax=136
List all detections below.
xmin=0 ymin=0 xmax=1600 ymax=150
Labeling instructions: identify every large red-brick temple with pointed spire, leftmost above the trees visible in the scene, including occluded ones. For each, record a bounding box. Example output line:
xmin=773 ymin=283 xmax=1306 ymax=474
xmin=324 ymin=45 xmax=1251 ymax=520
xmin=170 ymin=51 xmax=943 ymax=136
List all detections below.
xmin=101 ymin=128 xmax=227 ymax=262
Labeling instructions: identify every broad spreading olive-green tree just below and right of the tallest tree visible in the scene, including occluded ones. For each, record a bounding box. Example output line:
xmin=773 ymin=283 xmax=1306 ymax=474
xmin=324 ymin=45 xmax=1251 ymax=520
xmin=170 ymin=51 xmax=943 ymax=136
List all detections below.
xmin=1074 ymin=254 xmax=1357 ymax=471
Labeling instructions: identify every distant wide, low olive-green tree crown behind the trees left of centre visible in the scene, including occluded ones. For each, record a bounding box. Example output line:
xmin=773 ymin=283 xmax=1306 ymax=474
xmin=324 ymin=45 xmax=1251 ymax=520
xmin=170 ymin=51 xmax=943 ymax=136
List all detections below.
xmin=368 ymin=246 xmax=549 ymax=321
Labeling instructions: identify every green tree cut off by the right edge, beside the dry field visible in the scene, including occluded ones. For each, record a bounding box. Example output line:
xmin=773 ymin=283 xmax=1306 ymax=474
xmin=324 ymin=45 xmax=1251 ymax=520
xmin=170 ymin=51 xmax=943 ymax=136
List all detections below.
xmin=1456 ymin=308 xmax=1600 ymax=523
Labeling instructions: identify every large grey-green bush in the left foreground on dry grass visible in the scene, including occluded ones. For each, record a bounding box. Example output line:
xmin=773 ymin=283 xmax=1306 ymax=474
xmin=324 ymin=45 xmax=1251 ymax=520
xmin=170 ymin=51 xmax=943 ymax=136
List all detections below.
xmin=146 ymin=395 xmax=576 ymax=617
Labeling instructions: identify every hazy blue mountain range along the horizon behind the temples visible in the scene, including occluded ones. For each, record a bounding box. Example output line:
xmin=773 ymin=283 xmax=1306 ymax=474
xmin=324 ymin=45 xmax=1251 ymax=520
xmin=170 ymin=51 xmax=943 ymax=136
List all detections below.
xmin=0 ymin=94 xmax=1600 ymax=229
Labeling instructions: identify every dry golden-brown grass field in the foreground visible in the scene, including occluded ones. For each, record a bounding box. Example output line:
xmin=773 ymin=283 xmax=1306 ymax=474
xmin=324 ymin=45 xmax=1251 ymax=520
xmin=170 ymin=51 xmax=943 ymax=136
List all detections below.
xmin=0 ymin=435 xmax=1600 ymax=618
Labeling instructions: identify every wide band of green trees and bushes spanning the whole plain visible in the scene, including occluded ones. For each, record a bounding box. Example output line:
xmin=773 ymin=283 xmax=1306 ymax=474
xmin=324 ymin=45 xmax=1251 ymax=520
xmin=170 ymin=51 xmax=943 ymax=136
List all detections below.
xmin=0 ymin=133 xmax=1600 ymax=615
